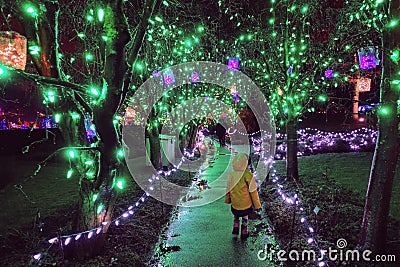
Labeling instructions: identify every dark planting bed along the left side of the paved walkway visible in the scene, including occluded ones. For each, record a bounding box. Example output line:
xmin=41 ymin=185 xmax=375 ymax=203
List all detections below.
xmin=0 ymin=162 xmax=193 ymax=267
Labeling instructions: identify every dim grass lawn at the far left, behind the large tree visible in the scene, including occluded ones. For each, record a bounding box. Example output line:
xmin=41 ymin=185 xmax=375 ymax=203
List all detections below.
xmin=0 ymin=155 xmax=79 ymax=237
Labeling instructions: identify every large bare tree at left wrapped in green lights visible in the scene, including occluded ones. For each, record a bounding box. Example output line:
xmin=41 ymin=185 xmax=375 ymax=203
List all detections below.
xmin=1 ymin=0 xmax=159 ymax=257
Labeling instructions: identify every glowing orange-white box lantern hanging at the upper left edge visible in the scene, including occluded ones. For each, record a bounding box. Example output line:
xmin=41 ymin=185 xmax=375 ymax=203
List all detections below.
xmin=0 ymin=31 xmax=27 ymax=70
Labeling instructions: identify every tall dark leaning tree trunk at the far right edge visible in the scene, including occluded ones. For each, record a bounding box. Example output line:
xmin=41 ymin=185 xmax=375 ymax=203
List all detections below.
xmin=359 ymin=1 xmax=400 ymax=253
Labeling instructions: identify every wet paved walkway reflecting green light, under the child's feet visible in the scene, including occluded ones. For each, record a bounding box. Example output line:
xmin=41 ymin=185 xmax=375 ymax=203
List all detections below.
xmin=153 ymin=145 xmax=275 ymax=266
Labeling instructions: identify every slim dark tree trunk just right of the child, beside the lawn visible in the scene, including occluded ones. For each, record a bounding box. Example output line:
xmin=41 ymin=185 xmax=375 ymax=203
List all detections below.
xmin=286 ymin=118 xmax=299 ymax=181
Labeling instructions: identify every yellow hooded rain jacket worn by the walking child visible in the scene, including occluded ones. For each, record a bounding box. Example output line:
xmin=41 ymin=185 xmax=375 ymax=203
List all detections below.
xmin=225 ymin=153 xmax=261 ymax=210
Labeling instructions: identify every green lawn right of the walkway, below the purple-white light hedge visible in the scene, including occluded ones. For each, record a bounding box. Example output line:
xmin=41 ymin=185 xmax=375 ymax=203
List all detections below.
xmin=276 ymin=152 xmax=400 ymax=220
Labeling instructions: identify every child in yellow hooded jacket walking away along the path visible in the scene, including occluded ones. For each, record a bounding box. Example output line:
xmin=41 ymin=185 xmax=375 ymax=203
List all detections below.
xmin=225 ymin=153 xmax=261 ymax=239
